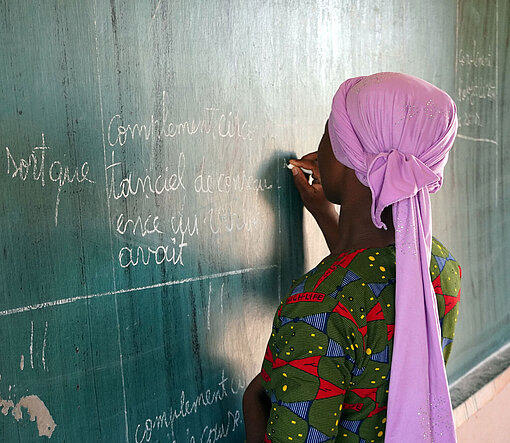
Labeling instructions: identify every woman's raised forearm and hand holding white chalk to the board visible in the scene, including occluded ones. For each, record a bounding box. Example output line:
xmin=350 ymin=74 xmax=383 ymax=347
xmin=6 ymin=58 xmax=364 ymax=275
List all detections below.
xmin=290 ymin=152 xmax=339 ymax=251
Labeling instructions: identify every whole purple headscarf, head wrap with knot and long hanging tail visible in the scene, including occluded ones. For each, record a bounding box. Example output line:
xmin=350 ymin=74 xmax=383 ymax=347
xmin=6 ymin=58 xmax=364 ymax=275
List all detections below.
xmin=328 ymin=72 xmax=457 ymax=443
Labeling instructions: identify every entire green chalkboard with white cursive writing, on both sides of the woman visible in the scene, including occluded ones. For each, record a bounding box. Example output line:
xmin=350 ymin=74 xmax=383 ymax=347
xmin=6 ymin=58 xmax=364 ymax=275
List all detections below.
xmin=0 ymin=0 xmax=510 ymax=443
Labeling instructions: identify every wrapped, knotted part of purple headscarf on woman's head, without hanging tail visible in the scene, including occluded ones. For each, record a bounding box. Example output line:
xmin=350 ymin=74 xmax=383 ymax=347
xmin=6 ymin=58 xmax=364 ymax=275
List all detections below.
xmin=328 ymin=72 xmax=457 ymax=227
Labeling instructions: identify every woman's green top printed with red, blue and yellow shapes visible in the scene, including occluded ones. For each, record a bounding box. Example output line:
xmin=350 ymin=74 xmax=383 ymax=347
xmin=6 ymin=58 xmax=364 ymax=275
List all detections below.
xmin=262 ymin=239 xmax=461 ymax=443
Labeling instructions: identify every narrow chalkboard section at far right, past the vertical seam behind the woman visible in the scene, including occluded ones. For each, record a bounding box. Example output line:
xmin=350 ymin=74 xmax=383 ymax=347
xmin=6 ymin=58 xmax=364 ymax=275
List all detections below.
xmin=435 ymin=0 xmax=510 ymax=381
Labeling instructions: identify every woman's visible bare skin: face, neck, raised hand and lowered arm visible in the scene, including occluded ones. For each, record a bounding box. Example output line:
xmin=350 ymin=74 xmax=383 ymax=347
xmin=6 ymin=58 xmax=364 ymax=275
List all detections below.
xmin=243 ymin=123 xmax=395 ymax=443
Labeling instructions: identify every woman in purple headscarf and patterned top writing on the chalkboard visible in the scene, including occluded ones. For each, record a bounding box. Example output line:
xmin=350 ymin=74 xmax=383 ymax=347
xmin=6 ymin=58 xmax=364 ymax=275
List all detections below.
xmin=243 ymin=73 xmax=461 ymax=443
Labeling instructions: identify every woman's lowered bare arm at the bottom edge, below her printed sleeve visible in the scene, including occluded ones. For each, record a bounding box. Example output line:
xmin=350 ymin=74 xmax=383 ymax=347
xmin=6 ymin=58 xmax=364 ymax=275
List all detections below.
xmin=243 ymin=373 xmax=271 ymax=443
